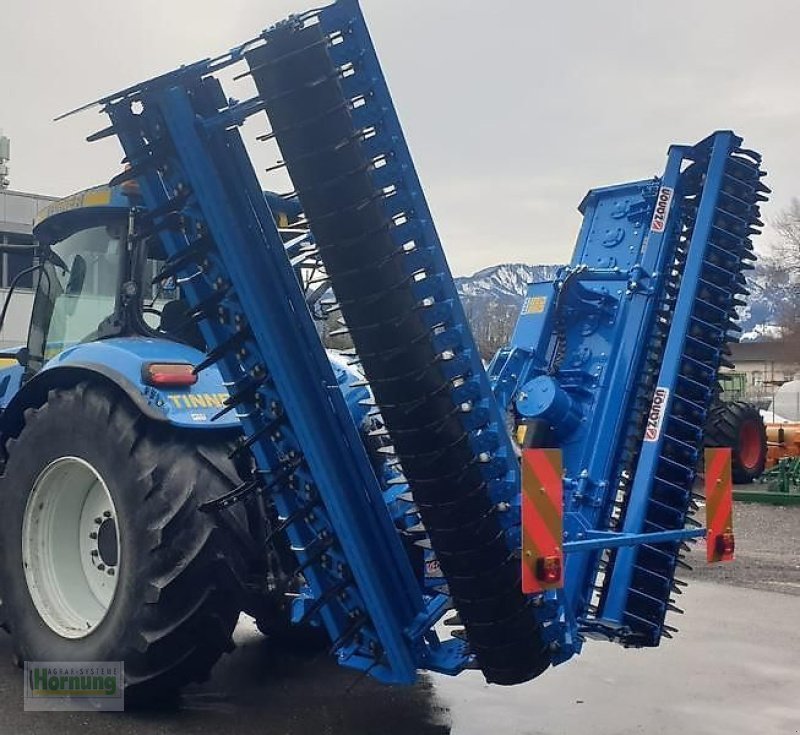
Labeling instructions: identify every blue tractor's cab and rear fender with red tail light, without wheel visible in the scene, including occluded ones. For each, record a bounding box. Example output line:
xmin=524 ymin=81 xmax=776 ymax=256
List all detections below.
xmin=0 ymin=182 xmax=316 ymax=432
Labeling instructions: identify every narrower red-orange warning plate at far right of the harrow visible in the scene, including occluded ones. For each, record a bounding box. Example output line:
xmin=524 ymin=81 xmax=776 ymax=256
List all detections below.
xmin=705 ymin=447 xmax=735 ymax=564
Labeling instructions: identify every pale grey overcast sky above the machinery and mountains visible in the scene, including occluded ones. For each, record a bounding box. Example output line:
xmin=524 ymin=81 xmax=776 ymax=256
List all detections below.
xmin=0 ymin=0 xmax=800 ymax=274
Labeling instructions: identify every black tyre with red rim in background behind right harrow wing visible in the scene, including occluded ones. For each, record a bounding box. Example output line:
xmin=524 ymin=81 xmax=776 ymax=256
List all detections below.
xmin=705 ymin=401 xmax=767 ymax=485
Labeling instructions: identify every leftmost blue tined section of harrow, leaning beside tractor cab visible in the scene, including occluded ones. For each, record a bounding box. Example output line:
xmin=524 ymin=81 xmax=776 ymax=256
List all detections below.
xmin=97 ymin=67 xmax=438 ymax=682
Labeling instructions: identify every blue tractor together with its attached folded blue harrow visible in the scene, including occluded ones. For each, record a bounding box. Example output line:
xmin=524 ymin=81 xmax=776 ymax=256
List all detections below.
xmin=0 ymin=0 xmax=768 ymax=697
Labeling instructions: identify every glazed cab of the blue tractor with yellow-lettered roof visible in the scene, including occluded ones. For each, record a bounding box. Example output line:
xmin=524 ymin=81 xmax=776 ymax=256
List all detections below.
xmin=20 ymin=184 xmax=300 ymax=378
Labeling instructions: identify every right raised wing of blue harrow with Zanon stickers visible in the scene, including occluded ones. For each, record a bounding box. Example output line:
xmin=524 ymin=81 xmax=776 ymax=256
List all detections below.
xmin=489 ymin=132 xmax=769 ymax=655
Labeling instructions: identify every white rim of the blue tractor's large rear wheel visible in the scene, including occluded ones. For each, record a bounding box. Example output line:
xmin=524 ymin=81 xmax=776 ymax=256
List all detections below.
xmin=22 ymin=457 xmax=120 ymax=639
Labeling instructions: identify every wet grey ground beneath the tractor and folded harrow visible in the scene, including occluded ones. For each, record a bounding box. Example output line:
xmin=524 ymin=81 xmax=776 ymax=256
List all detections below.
xmin=0 ymin=504 xmax=800 ymax=735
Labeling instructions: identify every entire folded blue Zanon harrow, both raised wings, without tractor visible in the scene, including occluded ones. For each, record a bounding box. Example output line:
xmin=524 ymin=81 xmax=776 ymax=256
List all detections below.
xmin=79 ymin=0 xmax=765 ymax=684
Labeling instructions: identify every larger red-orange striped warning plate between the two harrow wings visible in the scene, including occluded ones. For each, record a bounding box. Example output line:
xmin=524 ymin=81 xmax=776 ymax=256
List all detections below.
xmin=521 ymin=449 xmax=564 ymax=594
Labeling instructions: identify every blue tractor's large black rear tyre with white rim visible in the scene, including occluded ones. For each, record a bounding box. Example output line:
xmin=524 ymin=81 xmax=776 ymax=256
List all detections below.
xmin=0 ymin=383 xmax=246 ymax=702
